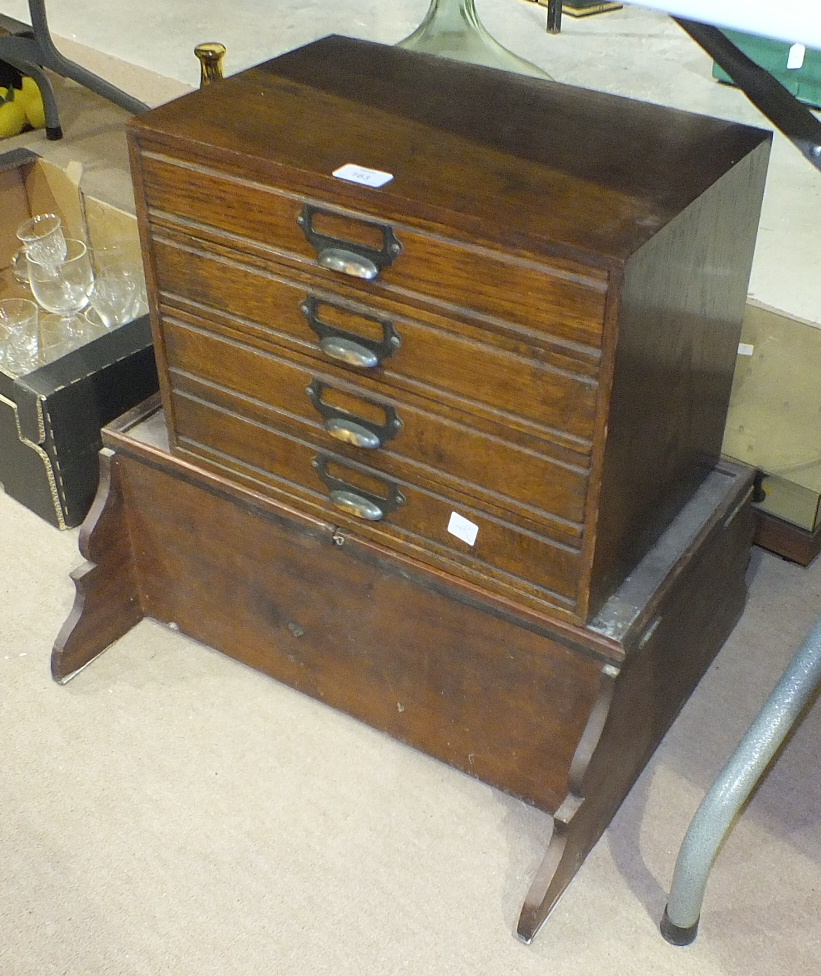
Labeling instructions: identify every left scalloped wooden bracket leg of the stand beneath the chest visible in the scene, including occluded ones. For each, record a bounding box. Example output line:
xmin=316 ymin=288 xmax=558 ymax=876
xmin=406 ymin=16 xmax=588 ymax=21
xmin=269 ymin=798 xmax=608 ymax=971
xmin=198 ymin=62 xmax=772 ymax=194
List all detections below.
xmin=51 ymin=448 xmax=144 ymax=684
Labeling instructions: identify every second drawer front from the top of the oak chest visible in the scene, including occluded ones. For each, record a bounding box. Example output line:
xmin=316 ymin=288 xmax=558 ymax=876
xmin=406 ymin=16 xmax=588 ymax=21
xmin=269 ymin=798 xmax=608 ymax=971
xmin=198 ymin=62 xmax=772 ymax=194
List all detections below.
xmin=149 ymin=240 xmax=598 ymax=452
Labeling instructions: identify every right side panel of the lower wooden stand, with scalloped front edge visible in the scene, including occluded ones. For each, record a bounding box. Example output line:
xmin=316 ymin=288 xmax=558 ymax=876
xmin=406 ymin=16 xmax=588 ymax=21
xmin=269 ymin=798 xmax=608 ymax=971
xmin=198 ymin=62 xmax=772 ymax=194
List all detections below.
xmin=517 ymin=484 xmax=753 ymax=942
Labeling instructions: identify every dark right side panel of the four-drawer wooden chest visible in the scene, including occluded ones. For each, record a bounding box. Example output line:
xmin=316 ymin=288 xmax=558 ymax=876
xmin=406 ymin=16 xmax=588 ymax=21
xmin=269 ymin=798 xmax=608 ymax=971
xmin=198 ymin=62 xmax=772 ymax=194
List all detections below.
xmin=592 ymin=145 xmax=769 ymax=605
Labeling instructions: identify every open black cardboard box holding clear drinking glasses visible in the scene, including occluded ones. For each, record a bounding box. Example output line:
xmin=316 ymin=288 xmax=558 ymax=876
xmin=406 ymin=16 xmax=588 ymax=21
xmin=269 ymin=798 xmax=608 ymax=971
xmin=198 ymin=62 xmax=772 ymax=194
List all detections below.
xmin=0 ymin=149 xmax=157 ymax=528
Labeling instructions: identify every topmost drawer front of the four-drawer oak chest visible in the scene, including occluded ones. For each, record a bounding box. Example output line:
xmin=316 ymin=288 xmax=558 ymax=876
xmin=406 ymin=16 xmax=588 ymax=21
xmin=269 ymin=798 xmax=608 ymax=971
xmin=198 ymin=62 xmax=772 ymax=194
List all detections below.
xmin=140 ymin=152 xmax=607 ymax=349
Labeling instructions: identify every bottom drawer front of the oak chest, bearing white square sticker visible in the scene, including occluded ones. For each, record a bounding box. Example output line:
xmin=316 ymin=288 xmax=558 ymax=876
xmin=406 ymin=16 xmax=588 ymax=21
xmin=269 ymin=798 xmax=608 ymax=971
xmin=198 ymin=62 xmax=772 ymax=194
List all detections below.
xmin=172 ymin=392 xmax=581 ymax=610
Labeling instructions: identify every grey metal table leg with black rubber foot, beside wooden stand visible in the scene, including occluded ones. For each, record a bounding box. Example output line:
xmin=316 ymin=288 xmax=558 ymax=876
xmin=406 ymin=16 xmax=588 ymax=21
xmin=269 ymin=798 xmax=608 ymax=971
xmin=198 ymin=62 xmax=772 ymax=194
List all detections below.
xmin=659 ymin=617 xmax=821 ymax=945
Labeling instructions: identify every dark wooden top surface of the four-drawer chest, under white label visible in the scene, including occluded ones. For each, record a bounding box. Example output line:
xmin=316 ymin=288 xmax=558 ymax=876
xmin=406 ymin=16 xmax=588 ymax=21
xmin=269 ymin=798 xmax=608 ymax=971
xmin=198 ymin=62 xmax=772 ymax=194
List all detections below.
xmin=131 ymin=35 xmax=771 ymax=267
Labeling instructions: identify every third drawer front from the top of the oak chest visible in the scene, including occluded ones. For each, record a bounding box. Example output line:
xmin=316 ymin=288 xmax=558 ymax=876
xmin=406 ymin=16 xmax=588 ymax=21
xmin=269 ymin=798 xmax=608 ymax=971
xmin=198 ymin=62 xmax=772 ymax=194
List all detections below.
xmin=163 ymin=315 xmax=587 ymax=545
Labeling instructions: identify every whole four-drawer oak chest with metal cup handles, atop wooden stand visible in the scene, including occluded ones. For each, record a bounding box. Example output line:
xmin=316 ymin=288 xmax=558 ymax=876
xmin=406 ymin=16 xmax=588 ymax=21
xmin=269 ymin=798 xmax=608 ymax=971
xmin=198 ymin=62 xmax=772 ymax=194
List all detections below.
xmin=129 ymin=37 xmax=770 ymax=623
